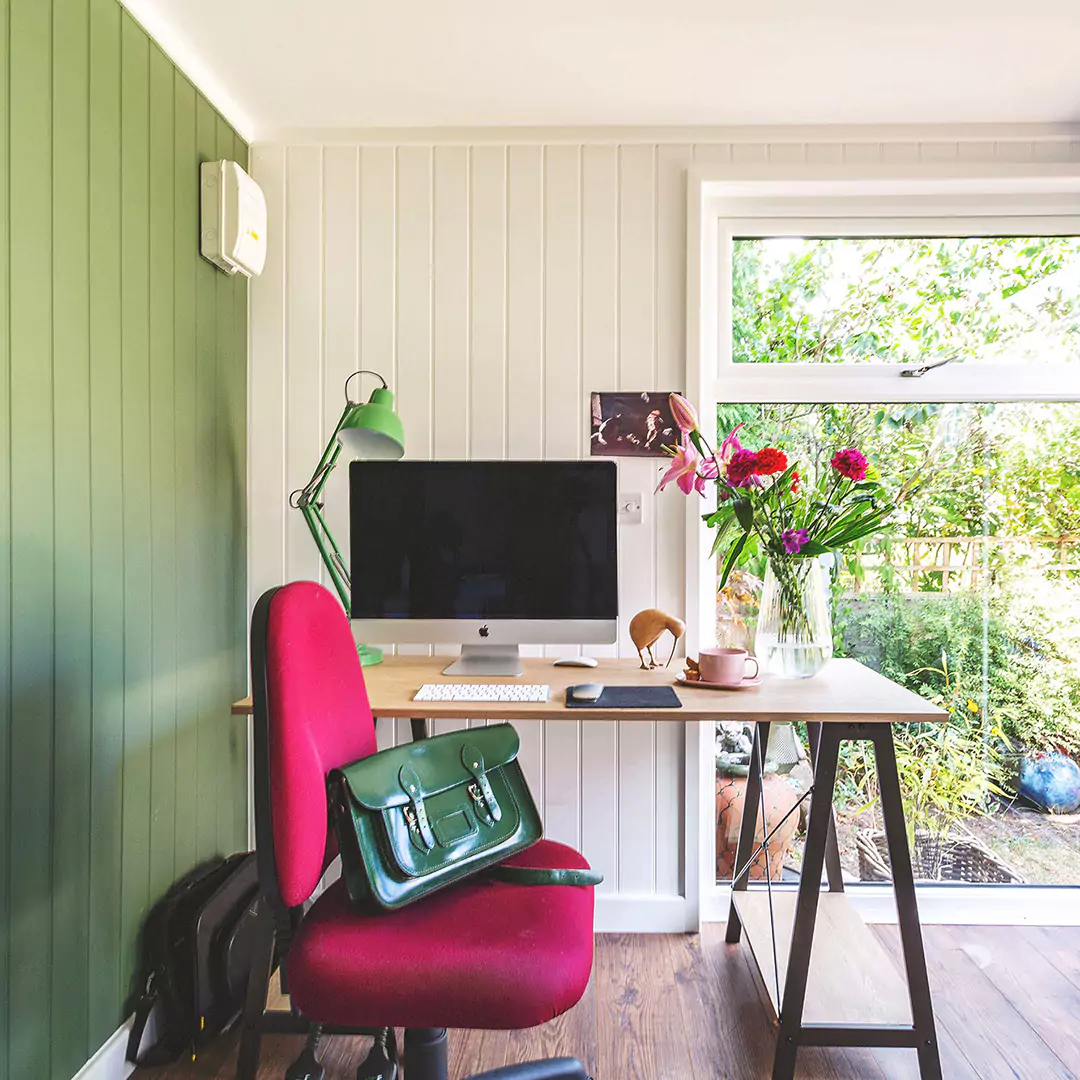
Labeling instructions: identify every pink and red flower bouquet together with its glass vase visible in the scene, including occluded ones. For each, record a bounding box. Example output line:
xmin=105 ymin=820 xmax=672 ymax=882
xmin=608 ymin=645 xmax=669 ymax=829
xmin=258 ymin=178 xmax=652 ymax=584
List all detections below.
xmin=659 ymin=394 xmax=893 ymax=678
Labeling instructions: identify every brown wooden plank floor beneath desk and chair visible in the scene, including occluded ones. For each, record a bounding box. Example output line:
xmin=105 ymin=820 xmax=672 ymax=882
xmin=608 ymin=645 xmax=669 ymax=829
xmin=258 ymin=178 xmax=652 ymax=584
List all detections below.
xmin=145 ymin=924 xmax=1080 ymax=1080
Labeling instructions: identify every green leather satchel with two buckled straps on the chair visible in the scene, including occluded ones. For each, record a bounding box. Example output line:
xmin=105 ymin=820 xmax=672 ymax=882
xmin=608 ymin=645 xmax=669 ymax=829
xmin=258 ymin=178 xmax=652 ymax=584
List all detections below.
xmin=327 ymin=724 xmax=602 ymax=909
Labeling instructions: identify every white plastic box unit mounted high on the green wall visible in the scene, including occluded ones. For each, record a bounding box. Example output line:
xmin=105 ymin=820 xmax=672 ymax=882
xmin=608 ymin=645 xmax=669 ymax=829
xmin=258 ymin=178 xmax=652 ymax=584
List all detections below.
xmin=200 ymin=161 xmax=267 ymax=278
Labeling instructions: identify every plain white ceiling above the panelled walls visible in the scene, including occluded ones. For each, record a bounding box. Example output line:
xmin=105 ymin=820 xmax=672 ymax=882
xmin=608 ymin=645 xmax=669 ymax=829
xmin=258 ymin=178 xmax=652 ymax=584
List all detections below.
xmin=135 ymin=0 xmax=1080 ymax=135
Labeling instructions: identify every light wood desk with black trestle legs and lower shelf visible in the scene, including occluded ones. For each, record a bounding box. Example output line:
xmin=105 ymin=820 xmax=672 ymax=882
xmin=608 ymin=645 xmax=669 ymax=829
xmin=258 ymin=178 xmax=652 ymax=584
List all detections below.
xmin=232 ymin=657 xmax=947 ymax=1080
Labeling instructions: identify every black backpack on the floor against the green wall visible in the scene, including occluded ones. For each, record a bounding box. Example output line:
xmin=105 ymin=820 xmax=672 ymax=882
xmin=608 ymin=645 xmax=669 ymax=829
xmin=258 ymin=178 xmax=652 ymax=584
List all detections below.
xmin=127 ymin=851 xmax=258 ymax=1065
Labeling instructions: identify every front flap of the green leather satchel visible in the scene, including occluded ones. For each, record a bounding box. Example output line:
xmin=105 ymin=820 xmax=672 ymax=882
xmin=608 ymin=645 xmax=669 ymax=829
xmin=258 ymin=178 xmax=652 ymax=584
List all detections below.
xmin=330 ymin=724 xmax=518 ymax=810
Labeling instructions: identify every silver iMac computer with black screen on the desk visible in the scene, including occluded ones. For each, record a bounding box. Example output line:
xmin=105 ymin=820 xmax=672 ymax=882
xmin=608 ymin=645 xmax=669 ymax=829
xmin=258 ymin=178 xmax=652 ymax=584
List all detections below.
xmin=349 ymin=461 xmax=619 ymax=675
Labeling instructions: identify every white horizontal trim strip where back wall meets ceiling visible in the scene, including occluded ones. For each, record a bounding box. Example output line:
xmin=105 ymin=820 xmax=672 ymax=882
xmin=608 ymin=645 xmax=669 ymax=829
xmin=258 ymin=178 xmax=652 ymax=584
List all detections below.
xmin=252 ymin=122 xmax=1080 ymax=149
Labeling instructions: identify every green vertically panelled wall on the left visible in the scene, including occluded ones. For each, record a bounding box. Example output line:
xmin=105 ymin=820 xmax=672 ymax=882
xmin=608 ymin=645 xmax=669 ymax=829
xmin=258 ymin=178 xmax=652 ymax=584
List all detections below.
xmin=0 ymin=0 xmax=247 ymax=1080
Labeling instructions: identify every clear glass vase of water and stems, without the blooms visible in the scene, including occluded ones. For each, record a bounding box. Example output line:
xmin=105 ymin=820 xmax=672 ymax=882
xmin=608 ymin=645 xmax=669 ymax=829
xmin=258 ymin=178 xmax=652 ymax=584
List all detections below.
xmin=755 ymin=558 xmax=833 ymax=678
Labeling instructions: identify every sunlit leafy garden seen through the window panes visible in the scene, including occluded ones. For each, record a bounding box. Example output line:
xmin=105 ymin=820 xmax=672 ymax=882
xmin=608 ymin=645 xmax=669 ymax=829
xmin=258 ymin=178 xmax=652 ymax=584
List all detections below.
xmin=716 ymin=238 xmax=1080 ymax=885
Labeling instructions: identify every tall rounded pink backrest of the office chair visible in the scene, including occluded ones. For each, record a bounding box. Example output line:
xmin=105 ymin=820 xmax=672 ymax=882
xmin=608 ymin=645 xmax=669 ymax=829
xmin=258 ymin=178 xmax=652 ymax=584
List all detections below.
xmin=252 ymin=581 xmax=376 ymax=907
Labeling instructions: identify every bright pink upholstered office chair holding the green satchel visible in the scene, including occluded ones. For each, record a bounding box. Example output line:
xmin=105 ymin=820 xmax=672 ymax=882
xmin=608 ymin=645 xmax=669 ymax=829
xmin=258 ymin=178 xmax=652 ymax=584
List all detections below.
xmin=244 ymin=581 xmax=593 ymax=1080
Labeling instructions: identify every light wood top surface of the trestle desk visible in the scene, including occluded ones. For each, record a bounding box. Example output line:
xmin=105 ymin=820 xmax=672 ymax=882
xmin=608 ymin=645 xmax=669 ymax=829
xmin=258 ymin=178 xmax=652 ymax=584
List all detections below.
xmin=232 ymin=657 xmax=947 ymax=724
